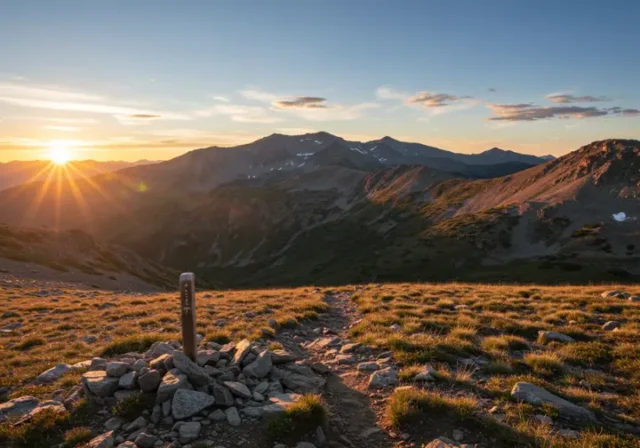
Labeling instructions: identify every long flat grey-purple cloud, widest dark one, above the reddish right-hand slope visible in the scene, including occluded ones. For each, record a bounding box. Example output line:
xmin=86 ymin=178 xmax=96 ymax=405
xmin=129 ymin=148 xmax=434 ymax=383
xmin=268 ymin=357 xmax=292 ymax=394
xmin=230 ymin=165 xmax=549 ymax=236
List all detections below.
xmin=488 ymin=103 xmax=609 ymax=121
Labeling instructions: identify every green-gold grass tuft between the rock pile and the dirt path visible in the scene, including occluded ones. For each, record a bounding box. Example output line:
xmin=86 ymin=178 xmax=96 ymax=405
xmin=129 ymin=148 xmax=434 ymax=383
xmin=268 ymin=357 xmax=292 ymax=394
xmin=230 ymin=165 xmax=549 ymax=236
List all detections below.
xmin=267 ymin=394 xmax=327 ymax=442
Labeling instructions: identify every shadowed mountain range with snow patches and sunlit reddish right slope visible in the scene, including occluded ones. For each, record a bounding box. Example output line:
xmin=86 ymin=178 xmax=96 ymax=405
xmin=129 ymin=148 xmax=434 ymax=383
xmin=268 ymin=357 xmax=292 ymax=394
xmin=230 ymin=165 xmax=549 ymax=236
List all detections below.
xmin=0 ymin=133 xmax=640 ymax=287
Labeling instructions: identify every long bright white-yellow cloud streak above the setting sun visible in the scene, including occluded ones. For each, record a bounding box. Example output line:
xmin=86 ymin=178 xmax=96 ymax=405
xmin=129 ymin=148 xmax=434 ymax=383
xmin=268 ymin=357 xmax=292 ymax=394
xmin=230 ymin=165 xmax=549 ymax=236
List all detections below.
xmin=0 ymin=83 xmax=190 ymax=122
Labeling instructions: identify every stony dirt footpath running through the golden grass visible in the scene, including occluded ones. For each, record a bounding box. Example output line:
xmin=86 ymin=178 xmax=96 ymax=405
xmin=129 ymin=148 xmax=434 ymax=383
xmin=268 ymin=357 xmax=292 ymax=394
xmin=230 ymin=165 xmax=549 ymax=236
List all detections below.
xmin=281 ymin=293 xmax=398 ymax=448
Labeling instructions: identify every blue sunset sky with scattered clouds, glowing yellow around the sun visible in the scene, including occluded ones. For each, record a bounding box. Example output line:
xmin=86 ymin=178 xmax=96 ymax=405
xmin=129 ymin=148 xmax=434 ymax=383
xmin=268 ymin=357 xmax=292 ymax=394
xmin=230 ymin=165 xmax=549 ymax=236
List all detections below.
xmin=0 ymin=0 xmax=640 ymax=162
